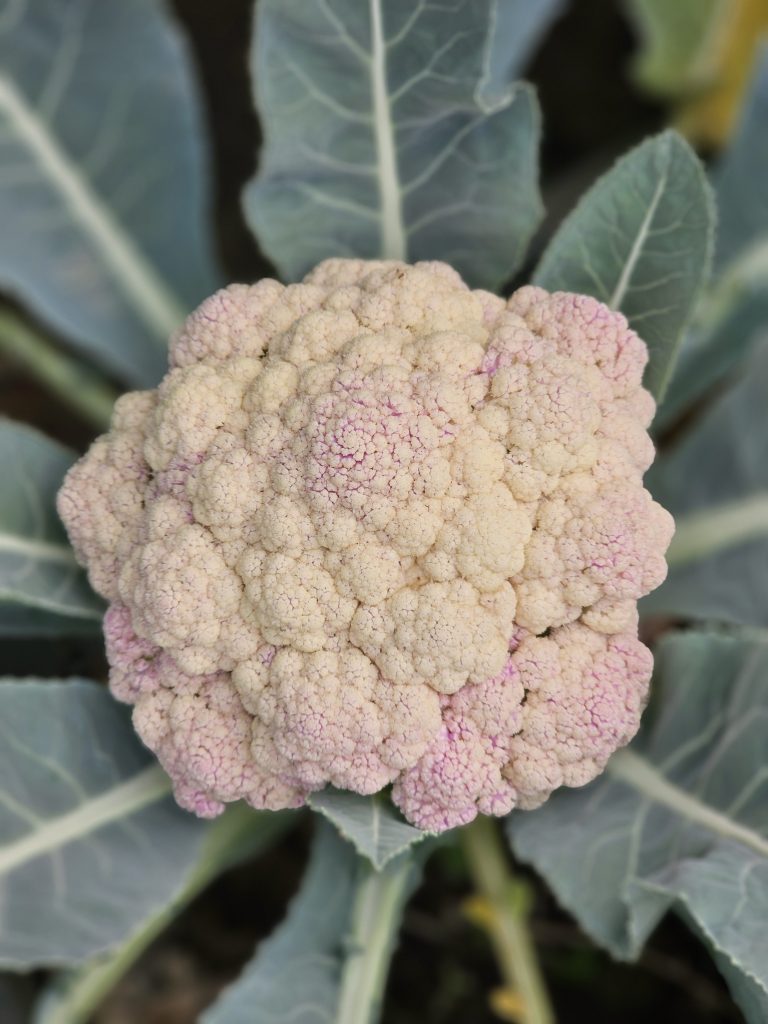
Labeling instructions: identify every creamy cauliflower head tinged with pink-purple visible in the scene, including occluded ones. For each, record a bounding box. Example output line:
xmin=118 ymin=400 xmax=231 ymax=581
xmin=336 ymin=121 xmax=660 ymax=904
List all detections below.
xmin=58 ymin=259 xmax=673 ymax=831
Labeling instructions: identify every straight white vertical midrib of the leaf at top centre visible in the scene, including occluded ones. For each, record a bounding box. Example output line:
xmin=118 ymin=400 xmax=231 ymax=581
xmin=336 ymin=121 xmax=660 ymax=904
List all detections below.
xmin=370 ymin=0 xmax=408 ymax=260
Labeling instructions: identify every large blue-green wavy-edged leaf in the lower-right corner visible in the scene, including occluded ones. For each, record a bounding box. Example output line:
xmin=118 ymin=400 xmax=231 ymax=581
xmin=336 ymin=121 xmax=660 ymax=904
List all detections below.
xmin=508 ymin=633 xmax=768 ymax=1024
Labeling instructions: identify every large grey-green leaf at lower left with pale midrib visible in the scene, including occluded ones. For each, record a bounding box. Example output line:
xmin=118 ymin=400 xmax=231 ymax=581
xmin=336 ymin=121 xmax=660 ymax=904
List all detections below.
xmin=0 ymin=680 xmax=206 ymax=970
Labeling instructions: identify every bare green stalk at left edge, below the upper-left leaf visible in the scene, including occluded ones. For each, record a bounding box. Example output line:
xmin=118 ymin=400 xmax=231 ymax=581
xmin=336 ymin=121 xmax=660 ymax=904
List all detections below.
xmin=0 ymin=310 xmax=118 ymax=430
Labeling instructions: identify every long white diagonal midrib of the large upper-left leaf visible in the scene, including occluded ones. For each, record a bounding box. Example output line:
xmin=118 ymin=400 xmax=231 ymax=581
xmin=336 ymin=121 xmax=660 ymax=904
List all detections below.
xmin=0 ymin=76 xmax=185 ymax=340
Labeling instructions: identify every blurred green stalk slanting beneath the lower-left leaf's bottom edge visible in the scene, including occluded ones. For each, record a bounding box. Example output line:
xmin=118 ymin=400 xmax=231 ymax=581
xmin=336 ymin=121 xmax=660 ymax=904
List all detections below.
xmin=34 ymin=804 xmax=293 ymax=1024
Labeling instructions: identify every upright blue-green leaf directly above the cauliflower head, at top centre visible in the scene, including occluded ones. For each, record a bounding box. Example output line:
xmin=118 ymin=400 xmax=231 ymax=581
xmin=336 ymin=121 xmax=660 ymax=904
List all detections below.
xmin=245 ymin=0 xmax=548 ymax=288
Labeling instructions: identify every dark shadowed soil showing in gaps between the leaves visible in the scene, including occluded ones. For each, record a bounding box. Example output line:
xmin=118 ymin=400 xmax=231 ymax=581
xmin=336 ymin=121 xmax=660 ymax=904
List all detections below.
xmin=0 ymin=0 xmax=740 ymax=1024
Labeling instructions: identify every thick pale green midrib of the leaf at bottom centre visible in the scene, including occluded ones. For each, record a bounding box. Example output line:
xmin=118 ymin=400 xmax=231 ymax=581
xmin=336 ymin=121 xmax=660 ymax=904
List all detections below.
xmin=335 ymin=854 xmax=415 ymax=1024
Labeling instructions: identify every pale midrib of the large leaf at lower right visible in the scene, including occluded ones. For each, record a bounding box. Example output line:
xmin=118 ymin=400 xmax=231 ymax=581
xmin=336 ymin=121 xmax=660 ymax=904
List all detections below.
xmin=606 ymin=751 xmax=768 ymax=857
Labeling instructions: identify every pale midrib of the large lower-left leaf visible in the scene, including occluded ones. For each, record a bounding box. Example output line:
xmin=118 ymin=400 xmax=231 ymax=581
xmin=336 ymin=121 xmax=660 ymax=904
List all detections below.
xmin=0 ymin=765 xmax=171 ymax=880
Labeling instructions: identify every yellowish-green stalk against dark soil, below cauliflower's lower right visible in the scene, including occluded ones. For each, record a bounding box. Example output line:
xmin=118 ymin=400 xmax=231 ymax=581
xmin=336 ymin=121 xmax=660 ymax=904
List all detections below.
xmin=460 ymin=816 xmax=555 ymax=1024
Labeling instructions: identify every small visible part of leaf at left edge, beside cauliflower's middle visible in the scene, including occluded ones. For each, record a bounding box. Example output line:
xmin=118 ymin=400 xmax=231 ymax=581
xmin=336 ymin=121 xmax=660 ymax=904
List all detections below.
xmin=0 ymin=420 xmax=103 ymax=635
